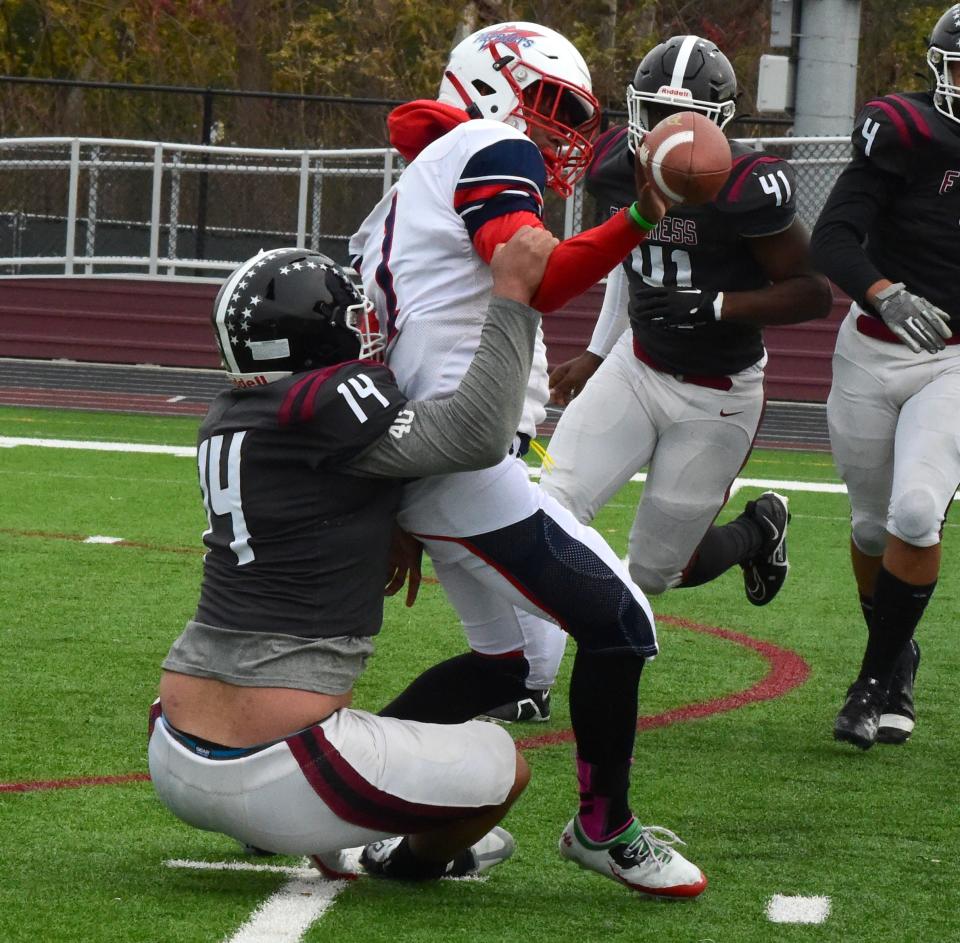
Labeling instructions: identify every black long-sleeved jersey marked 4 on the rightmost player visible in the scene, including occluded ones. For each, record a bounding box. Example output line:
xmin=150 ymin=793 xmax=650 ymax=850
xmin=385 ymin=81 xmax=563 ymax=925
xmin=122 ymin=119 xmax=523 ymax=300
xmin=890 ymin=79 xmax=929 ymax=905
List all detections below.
xmin=812 ymin=92 xmax=960 ymax=323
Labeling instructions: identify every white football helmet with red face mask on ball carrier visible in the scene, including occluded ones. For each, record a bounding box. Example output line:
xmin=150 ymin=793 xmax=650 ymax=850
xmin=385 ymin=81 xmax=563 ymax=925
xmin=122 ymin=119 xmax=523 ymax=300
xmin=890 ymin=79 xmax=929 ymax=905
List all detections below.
xmin=437 ymin=23 xmax=600 ymax=196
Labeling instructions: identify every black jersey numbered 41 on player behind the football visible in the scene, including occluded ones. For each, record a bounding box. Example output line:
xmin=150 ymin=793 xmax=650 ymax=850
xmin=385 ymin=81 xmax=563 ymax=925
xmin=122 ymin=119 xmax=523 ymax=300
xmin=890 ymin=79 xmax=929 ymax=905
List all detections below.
xmin=587 ymin=128 xmax=796 ymax=376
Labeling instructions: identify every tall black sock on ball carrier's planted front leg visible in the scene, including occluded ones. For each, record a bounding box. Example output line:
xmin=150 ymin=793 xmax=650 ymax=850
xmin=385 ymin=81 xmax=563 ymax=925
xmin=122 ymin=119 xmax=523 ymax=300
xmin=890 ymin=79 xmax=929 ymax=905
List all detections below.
xmin=570 ymin=648 xmax=643 ymax=837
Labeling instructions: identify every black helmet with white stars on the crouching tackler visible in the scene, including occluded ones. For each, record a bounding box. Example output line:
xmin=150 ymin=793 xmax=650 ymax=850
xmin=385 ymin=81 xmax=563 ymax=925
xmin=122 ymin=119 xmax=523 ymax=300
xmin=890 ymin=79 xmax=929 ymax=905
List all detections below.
xmin=212 ymin=249 xmax=385 ymax=387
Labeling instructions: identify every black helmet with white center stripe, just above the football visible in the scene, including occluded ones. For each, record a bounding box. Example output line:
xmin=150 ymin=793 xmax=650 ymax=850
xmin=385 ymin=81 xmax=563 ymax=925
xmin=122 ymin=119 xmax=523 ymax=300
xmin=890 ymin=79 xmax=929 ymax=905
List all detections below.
xmin=627 ymin=36 xmax=737 ymax=151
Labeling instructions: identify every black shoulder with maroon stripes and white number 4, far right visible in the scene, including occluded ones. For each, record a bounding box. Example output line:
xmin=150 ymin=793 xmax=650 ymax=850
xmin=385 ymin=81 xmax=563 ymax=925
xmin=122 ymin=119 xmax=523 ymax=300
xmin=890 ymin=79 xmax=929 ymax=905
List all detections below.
xmin=850 ymin=92 xmax=936 ymax=177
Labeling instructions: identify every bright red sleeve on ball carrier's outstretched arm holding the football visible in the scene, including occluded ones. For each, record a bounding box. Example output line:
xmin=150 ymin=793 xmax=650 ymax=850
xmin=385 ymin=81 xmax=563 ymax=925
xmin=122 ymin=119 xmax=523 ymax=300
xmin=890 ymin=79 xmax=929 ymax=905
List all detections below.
xmin=473 ymin=209 xmax=647 ymax=312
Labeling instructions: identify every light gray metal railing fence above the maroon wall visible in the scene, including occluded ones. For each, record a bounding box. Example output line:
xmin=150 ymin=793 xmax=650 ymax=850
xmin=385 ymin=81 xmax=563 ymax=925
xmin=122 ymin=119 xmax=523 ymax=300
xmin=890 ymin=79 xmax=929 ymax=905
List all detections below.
xmin=0 ymin=137 xmax=850 ymax=277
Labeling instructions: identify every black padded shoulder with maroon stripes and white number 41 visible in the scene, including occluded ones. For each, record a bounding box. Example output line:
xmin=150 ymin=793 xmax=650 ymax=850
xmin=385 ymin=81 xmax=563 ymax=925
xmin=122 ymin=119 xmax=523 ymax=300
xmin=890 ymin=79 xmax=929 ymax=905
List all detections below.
xmin=715 ymin=148 xmax=797 ymax=236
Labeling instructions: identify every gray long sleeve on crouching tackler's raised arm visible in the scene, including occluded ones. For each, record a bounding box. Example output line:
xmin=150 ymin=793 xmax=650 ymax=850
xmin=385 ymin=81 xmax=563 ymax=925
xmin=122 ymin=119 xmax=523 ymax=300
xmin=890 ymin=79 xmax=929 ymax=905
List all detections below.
xmin=346 ymin=296 xmax=540 ymax=478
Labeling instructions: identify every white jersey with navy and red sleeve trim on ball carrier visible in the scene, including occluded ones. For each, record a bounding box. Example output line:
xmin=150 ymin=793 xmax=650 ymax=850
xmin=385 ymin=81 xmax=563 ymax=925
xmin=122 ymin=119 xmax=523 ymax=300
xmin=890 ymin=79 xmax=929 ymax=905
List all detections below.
xmin=350 ymin=119 xmax=548 ymax=434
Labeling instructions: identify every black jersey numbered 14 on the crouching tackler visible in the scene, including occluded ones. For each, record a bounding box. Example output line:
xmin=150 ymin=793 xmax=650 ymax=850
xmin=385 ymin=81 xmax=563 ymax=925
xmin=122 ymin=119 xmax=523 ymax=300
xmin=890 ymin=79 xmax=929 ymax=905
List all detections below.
xmin=195 ymin=361 xmax=407 ymax=638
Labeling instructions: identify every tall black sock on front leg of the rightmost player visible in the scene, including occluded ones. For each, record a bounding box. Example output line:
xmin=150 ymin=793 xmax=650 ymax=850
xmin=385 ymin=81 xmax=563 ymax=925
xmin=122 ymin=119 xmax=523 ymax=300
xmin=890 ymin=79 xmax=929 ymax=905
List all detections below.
xmin=860 ymin=567 xmax=937 ymax=688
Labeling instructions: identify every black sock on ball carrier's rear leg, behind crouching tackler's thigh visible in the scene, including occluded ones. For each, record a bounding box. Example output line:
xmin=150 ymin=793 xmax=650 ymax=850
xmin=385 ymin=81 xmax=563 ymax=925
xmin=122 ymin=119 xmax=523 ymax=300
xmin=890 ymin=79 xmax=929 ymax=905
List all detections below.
xmin=380 ymin=652 xmax=530 ymax=724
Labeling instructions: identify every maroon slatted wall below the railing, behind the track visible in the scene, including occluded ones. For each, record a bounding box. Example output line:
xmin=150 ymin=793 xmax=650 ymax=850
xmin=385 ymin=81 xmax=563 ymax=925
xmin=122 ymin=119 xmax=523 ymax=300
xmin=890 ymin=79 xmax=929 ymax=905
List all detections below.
xmin=0 ymin=276 xmax=848 ymax=402
